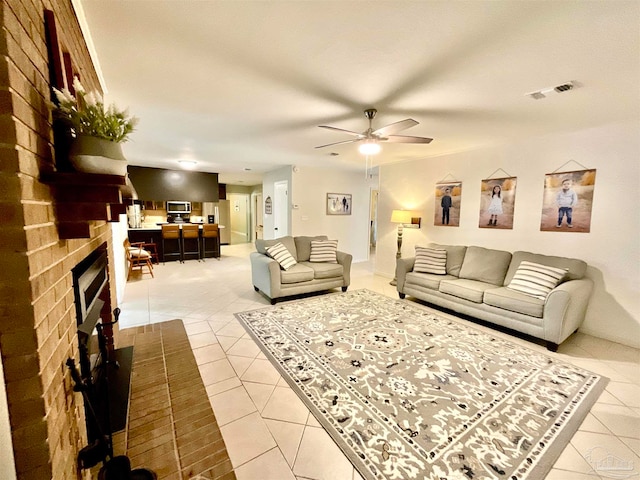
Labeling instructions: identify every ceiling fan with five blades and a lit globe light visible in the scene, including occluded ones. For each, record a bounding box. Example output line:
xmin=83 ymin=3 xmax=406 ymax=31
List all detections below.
xmin=316 ymin=108 xmax=433 ymax=155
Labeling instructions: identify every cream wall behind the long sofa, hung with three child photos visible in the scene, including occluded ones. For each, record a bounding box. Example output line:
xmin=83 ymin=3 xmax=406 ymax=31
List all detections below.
xmin=376 ymin=123 xmax=640 ymax=347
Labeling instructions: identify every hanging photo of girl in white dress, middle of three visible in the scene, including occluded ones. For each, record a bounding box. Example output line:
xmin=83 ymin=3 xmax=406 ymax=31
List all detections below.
xmin=478 ymin=177 xmax=518 ymax=230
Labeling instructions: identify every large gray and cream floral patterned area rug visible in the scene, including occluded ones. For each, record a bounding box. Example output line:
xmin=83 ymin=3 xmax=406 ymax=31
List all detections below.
xmin=236 ymin=290 xmax=607 ymax=480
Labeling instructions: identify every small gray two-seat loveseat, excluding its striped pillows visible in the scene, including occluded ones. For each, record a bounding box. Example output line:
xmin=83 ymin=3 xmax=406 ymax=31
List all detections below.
xmin=250 ymin=235 xmax=353 ymax=305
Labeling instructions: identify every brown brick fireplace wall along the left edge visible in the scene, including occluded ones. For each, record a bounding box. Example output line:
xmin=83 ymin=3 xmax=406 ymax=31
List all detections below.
xmin=0 ymin=0 xmax=115 ymax=480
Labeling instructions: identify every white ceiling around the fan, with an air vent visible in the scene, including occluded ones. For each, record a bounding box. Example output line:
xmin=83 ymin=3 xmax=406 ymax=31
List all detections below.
xmin=80 ymin=0 xmax=640 ymax=185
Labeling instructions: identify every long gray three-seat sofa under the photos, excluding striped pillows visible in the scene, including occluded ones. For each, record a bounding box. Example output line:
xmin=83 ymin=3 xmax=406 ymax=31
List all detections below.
xmin=396 ymin=243 xmax=593 ymax=351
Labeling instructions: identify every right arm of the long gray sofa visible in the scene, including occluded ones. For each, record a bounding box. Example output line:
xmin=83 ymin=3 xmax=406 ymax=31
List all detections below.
xmin=543 ymin=278 xmax=593 ymax=345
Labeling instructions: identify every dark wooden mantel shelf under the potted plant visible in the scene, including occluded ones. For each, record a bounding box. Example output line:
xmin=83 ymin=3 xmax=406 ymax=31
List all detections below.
xmin=40 ymin=172 xmax=127 ymax=239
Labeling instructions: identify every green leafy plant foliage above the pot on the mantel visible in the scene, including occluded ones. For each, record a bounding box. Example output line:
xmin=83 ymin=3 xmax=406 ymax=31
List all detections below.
xmin=53 ymin=77 xmax=138 ymax=143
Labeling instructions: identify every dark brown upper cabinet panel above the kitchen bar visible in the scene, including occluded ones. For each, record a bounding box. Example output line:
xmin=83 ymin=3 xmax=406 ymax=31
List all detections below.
xmin=128 ymin=166 xmax=219 ymax=202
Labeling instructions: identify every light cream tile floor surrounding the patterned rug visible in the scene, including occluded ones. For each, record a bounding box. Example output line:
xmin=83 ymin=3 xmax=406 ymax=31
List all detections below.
xmin=120 ymin=244 xmax=640 ymax=480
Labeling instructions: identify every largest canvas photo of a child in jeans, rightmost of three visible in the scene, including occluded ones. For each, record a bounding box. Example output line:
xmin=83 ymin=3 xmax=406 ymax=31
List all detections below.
xmin=540 ymin=169 xmax=596 ymax=233
